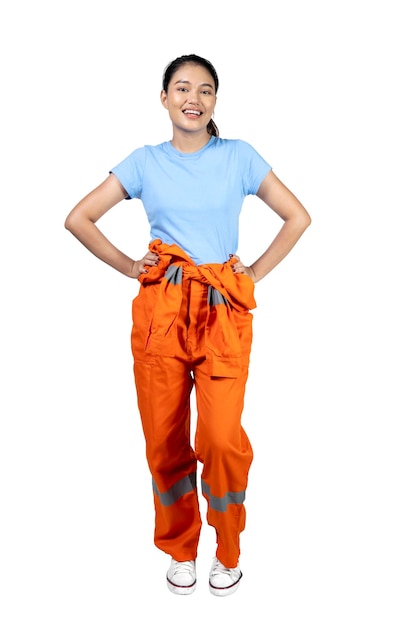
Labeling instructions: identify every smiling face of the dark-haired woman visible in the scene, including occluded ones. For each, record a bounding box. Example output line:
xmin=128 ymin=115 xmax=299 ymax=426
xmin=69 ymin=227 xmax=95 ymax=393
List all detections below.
xmin=161 ymin=63 xmax=216 ymax=134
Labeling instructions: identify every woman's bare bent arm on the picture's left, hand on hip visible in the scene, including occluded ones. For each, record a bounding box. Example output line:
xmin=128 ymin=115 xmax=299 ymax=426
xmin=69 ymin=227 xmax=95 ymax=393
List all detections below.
xmin=65 ymin=174 xmax=158 ymax=278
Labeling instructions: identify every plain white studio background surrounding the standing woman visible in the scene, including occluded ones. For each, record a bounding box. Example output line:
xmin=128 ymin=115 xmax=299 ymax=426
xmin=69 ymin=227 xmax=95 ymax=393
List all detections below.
xmin=0 ymin=0 xmax=417 ymax=626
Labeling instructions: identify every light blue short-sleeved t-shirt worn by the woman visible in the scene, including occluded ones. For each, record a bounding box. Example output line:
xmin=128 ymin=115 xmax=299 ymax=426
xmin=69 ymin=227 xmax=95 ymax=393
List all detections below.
xmin=111 ymin=137 xmax=271 ymax=265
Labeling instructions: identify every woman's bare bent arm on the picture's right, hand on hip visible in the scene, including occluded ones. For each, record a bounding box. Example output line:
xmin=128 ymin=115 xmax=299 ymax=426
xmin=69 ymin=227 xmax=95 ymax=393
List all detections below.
xmin=234 ymin=171 xmax=311 ymax=282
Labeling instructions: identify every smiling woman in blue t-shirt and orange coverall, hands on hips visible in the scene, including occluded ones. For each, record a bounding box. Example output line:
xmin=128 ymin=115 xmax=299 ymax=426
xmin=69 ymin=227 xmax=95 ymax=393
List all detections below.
xmin=65 ymin=54 xmax=310 ymax=596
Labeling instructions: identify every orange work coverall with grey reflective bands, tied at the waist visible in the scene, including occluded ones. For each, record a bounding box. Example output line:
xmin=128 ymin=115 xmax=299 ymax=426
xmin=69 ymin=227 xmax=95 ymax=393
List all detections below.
xmin=132 ymin=240 xmax=256 ymax=567
